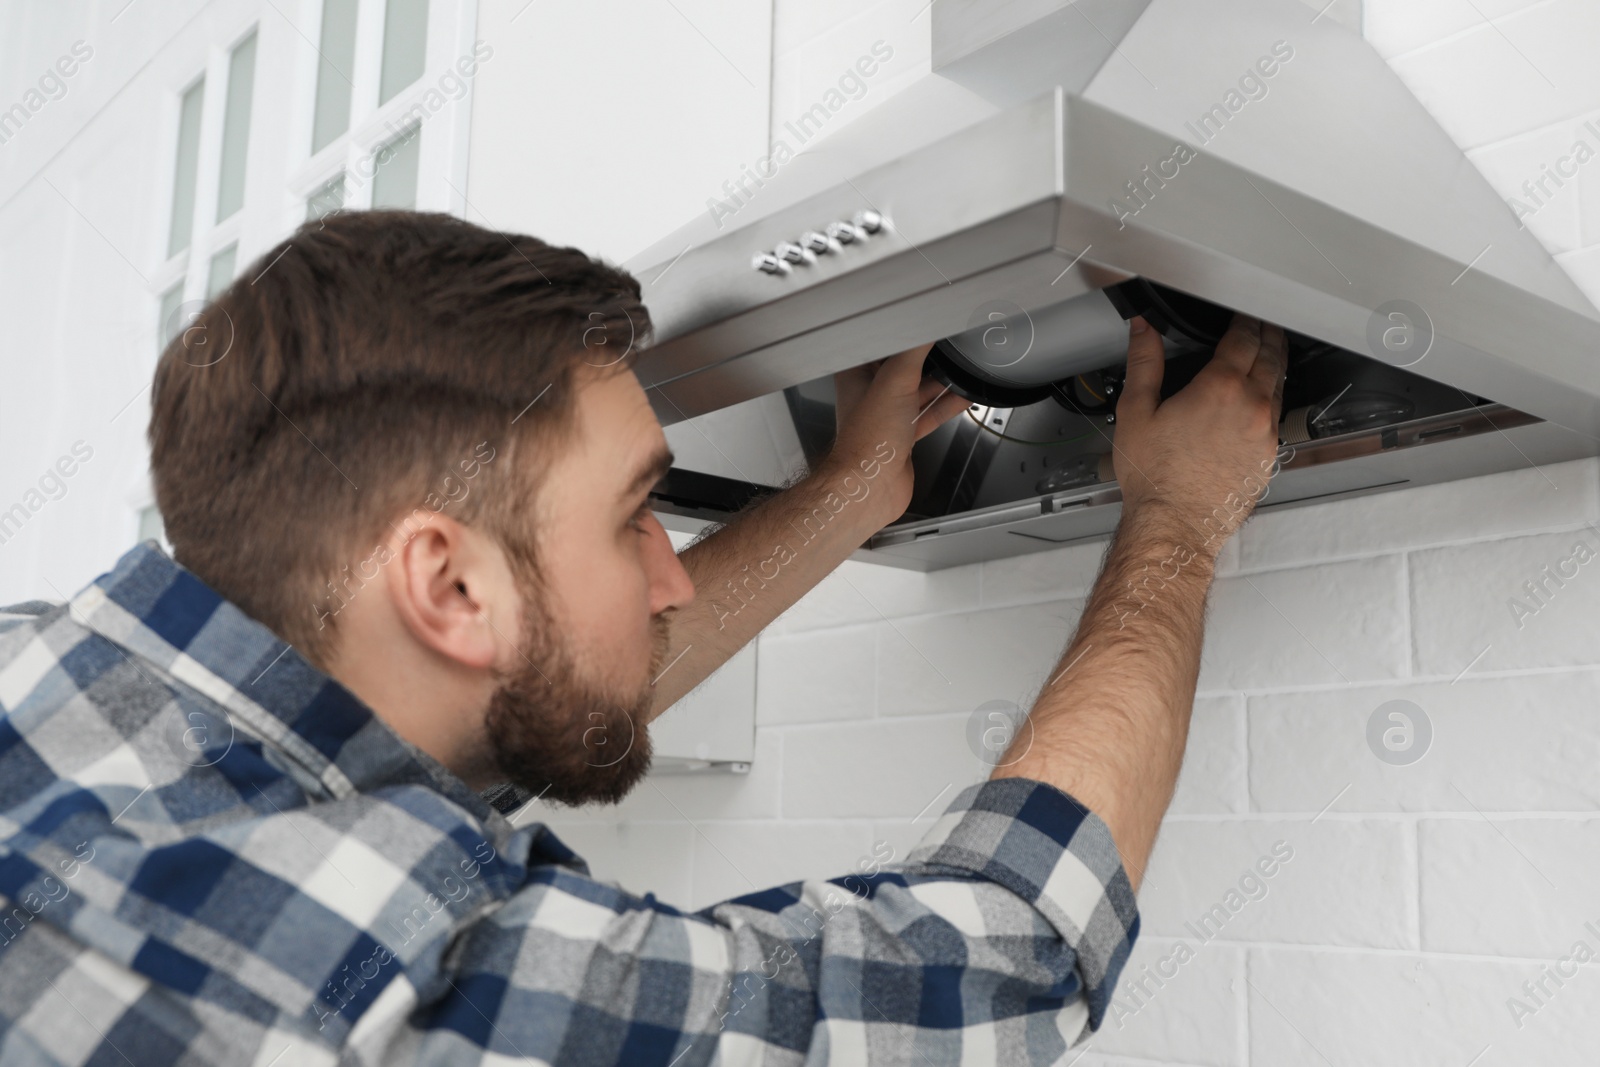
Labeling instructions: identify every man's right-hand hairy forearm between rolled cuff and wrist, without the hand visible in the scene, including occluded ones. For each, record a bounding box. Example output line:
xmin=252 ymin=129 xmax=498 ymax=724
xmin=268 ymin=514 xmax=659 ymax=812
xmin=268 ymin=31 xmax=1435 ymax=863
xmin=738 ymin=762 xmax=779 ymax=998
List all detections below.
xmin=994 ymin=509 xmax=1214 ymax=886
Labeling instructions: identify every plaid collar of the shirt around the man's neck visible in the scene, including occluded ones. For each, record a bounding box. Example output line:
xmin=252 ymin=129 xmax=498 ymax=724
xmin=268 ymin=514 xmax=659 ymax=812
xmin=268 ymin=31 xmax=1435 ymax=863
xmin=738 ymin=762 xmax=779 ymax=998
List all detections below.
xmin=70 ymin=541 xmax=509 ymax=830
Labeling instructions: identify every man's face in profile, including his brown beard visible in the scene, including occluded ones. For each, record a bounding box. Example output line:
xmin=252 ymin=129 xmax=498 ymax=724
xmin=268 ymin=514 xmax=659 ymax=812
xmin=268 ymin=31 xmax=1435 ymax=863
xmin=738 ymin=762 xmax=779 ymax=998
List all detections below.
xmin=486 ymin=370 xmax=694 ymax=803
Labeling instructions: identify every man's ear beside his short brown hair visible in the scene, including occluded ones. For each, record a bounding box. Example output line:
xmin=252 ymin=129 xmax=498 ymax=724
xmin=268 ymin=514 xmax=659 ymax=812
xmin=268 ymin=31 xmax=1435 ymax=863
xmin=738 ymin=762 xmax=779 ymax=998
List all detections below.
xmin=387 ymin=515 xmax=522 ymax=670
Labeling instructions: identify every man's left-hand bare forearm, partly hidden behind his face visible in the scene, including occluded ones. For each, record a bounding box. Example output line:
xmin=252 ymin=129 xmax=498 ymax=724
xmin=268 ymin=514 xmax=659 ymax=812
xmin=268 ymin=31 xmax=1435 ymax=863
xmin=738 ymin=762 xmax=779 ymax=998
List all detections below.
xmin=651 ymin=443 xmax=896 ymax=715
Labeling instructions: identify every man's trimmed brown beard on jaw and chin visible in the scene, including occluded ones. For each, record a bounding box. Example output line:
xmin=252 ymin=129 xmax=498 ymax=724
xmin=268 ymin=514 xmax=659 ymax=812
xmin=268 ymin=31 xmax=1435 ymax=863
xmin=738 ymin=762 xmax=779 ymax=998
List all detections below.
xmin=485 ymin=577 xmax=669 ymax=806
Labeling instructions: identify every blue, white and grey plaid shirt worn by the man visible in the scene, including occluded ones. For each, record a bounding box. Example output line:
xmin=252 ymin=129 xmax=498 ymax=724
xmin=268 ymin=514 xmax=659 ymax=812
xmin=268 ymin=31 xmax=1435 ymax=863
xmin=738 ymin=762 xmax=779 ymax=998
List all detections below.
xmin=0 ymin=542 xmax=1138 ymax=1067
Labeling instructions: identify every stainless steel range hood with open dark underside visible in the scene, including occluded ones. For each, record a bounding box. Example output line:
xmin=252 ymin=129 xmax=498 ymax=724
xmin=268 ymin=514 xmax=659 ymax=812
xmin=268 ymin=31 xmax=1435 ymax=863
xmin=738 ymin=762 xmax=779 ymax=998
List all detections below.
xmin=627 ymin=0 xmax=1600 ymax=568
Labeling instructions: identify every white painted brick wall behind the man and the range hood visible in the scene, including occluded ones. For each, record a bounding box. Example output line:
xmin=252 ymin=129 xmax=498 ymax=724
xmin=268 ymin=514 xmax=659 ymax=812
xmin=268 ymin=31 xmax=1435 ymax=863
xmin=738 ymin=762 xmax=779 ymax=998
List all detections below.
xmin=524 ymin=0 xmax=1600 ymax=1067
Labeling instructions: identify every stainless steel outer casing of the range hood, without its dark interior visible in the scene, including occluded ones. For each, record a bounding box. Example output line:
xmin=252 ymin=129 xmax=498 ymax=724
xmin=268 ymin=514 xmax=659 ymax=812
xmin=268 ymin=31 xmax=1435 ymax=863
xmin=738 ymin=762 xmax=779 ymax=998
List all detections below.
xmin=629 ymin=0 xmax=1600 ymax=572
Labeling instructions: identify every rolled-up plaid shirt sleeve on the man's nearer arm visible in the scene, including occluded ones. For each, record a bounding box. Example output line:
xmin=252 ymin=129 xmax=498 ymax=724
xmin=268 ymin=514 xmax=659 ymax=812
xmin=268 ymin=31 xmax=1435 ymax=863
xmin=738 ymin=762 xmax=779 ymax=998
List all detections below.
xmin=380 ymin=779 xmax=1139 ymax=1067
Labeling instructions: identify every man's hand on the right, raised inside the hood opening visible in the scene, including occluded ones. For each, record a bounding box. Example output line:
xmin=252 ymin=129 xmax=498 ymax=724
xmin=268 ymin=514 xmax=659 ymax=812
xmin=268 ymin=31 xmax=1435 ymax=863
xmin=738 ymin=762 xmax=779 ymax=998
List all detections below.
xmin=1112 ymin=308 xmax=1288 ymax=543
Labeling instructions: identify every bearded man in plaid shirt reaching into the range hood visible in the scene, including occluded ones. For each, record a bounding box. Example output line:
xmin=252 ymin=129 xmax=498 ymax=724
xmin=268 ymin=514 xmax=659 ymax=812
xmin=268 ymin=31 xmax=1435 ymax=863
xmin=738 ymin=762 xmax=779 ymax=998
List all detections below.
xmin=0 ymin=213 xmax=1283 ymax=1065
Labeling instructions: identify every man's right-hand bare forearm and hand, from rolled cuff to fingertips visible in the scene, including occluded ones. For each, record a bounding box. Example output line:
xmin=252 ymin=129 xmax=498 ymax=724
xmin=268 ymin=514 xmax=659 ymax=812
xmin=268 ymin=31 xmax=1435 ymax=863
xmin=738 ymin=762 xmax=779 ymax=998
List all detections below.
xmin=994 ymin=317 xmax=1285 ymax=888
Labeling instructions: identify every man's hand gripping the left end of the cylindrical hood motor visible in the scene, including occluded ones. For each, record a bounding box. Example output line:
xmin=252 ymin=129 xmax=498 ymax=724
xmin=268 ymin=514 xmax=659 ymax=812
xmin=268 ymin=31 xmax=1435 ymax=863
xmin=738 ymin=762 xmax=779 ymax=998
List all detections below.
xmin=827 ymin=344 xmax=968 ymax=523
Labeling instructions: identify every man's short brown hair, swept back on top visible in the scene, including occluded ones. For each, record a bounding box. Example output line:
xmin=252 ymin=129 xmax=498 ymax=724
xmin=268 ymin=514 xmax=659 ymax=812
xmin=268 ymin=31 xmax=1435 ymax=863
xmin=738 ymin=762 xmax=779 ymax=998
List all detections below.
xmin=149 ymin=211 xmax=650 ymax=667
